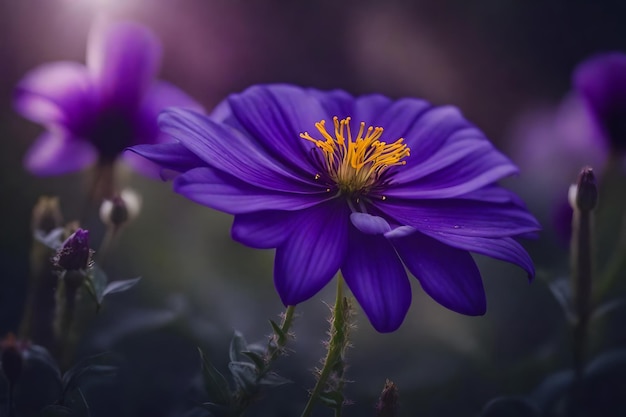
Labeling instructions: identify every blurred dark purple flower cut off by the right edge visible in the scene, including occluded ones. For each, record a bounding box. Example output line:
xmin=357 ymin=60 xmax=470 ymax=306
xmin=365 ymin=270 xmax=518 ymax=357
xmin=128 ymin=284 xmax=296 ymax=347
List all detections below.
xmin=574 ymin=52 xmax=626 ymax=152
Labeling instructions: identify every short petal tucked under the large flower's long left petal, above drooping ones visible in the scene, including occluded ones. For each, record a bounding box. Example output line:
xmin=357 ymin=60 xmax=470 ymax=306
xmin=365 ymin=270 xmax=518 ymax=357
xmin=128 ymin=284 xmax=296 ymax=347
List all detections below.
xmin=231 ymin=210 xmax=306 ymax=249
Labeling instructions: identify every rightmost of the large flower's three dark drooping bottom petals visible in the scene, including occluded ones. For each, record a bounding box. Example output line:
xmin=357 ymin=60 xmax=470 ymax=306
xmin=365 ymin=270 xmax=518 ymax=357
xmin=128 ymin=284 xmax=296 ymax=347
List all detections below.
xmin=392 ymin=233 xmax=487 ymax=316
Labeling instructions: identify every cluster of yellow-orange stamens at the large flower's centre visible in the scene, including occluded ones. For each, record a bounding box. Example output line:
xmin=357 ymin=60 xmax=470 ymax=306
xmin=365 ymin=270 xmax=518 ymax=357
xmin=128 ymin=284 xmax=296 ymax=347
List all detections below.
xmin=300 ymin=116 xmax=410 ymax=196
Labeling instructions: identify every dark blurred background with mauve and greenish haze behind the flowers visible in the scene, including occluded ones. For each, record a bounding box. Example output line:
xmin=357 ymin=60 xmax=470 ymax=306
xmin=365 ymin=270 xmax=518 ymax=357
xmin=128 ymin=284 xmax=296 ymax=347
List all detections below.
xmin=0 ymin=0 xmax=626 ymax=417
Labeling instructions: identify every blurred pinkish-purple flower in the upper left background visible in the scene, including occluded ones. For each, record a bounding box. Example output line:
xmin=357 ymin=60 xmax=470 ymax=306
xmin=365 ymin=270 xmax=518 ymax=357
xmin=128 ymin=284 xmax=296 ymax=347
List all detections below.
xmin=15 ymin=22 xmax=200 ymax=175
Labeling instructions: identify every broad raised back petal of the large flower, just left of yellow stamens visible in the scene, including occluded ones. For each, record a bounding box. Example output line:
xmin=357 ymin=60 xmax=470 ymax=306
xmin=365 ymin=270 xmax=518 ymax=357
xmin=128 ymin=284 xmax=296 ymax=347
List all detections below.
xmin=228 ymin=84 xmax=332 ymax=175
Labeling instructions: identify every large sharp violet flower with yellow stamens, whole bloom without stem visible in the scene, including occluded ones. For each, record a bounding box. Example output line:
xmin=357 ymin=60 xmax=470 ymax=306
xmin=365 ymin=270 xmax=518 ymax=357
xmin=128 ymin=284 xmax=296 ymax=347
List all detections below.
xmin=132 ymin=85 xmax=539 ymax=332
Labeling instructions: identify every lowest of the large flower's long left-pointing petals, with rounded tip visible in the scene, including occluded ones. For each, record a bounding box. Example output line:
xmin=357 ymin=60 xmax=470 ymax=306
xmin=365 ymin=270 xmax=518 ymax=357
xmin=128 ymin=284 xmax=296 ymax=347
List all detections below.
xmin=174 ymin=167 xmax=332 ymax=214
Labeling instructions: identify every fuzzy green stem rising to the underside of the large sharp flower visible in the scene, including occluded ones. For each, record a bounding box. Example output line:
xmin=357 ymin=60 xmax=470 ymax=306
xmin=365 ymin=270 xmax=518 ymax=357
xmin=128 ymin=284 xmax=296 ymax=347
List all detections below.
xmin=300 ymin=276 xmax=347 ymax=417
